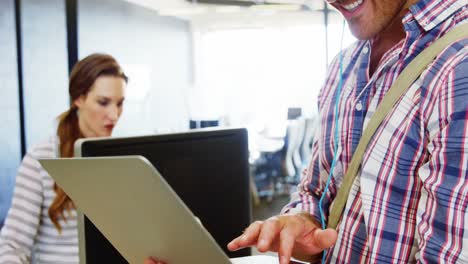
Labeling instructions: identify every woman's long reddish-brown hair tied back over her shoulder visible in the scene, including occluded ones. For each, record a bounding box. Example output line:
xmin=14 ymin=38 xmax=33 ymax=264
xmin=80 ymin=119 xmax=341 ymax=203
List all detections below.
xmin=49 ymin=53 xmax=128 ymax=232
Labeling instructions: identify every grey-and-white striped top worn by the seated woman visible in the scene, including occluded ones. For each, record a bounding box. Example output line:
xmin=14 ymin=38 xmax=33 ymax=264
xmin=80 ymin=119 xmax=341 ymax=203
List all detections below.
xmin=0 ymin=139 xmax=79 ymax=264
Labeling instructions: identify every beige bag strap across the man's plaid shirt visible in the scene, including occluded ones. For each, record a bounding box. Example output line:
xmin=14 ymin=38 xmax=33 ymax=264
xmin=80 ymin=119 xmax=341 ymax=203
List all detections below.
xmin=328 ymin=24 xmax=468 ymax=229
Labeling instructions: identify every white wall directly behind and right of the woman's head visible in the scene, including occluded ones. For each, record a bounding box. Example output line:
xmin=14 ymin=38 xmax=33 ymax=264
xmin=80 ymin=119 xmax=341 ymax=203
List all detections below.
xmin=78 ymin=0 xmax=192 ymax=135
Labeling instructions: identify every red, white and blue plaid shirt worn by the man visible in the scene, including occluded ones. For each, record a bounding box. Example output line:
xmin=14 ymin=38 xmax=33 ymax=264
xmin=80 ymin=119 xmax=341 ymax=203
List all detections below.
xmin=283 ymin=0 xmax=468 ymax=263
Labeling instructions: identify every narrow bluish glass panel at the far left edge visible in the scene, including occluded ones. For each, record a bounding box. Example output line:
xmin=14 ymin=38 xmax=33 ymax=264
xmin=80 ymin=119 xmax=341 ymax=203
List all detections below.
xmin=0 ymin=0 xmax=21 ymax=227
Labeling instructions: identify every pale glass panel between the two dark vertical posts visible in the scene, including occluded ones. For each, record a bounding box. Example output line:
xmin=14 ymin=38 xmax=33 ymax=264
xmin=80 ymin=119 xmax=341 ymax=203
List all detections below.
xmin=21 ymin=0 xmax=69 ymax=149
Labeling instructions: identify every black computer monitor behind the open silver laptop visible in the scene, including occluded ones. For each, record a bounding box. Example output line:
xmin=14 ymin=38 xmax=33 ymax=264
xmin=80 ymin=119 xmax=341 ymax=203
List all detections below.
xmin=75 ymin=128 xmax=251 ymax=264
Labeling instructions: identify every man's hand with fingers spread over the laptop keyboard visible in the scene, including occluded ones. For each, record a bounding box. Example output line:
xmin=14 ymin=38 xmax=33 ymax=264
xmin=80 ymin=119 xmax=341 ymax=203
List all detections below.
xmin=228 ymin=213 xmax=338 ymax=264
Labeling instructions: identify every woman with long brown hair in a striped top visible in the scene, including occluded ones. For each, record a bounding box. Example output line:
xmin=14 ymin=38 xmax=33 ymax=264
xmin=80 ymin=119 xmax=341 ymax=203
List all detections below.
xmin=0 ymin=54 xmax=128 ymax=263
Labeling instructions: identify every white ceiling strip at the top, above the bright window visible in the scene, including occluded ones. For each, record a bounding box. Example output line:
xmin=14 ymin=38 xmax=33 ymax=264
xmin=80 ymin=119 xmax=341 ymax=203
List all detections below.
xmin=125 ymin=0 xmax=330 ymax=30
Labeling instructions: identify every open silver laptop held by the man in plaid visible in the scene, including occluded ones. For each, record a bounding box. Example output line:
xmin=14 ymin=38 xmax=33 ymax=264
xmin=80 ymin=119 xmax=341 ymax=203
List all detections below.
xmin=39 ymin=156 xmax=288 ymax=264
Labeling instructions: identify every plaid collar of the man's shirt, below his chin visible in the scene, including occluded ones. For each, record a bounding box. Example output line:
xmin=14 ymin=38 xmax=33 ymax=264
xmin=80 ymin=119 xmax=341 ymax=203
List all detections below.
xmin=403 ymin=0 xmax=468 ymax=31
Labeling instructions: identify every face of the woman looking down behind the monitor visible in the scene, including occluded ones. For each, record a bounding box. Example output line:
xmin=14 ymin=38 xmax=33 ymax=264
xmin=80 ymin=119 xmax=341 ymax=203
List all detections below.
xmin=74 ymin=76 xmax=126 ymax=137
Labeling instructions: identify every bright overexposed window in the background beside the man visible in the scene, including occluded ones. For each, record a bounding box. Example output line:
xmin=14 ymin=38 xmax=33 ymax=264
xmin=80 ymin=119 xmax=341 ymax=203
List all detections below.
xmin=194 ymin=23 xmax=354 ymax=130
